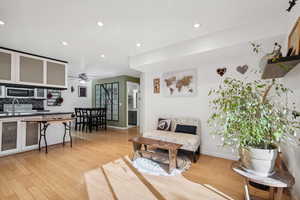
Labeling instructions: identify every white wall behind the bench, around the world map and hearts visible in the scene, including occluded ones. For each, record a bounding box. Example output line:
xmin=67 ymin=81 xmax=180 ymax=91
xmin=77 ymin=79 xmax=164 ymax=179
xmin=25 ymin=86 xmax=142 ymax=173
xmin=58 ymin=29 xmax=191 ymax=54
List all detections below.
xmin=141 ymin=36 xmax=284 ymax=159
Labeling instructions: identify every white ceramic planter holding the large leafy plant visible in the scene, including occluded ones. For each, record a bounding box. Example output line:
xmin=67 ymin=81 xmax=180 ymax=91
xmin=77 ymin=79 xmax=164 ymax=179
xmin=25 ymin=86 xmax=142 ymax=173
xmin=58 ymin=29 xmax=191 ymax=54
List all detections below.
xmin=240 ymin=147 xmax=278 ymax=176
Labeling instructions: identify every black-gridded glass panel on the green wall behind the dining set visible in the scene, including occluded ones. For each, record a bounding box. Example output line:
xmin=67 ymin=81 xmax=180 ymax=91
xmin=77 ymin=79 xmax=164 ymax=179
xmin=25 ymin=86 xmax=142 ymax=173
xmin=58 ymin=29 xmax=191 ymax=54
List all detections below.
xmin=95 ymin=82 xmax=119 ymax=121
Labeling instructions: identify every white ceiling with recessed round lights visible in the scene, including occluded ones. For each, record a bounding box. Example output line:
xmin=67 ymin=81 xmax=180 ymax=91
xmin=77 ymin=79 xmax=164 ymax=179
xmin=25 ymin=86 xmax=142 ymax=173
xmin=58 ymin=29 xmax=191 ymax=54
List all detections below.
xmin=0 ymin=0 xmax=288 ymax=77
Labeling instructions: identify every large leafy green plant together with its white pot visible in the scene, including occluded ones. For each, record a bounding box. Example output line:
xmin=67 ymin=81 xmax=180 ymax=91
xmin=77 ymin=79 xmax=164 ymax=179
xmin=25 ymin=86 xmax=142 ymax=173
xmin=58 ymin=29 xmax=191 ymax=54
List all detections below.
xmin=208 ymin=78 xmax=299 ymax=176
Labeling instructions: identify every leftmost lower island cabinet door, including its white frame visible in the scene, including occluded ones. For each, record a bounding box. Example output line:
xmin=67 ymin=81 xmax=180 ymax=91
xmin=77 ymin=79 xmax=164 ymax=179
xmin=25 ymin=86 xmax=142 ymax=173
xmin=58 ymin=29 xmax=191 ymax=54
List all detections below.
xmin=0 ymin=121 xmax=19 ymax=155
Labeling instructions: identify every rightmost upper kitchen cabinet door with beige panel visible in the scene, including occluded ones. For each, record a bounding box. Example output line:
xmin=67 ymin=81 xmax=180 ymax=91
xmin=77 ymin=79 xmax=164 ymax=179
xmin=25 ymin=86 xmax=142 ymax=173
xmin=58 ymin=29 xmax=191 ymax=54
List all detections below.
xmin=47 ymin=61 xmax=67 ymax=87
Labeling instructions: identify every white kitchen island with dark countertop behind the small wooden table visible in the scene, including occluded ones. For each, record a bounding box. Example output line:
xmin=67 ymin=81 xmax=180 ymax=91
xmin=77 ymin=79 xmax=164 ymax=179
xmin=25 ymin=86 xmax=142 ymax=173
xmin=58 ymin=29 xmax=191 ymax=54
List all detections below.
xmin=0 ymin=112 xmax=72 ymax=156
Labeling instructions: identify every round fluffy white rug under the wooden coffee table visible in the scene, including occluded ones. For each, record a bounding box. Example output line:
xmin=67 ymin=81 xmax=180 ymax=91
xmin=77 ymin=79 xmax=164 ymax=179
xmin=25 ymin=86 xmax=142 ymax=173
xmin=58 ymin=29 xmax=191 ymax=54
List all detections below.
xmin=132 ymin=152 xmax=191 ymax=176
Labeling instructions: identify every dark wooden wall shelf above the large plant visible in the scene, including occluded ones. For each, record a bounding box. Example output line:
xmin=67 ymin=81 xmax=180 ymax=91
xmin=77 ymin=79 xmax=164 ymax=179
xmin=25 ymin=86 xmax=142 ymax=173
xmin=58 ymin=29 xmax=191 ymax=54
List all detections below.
xmin=262 ymin=55 xmax=300 ymax=79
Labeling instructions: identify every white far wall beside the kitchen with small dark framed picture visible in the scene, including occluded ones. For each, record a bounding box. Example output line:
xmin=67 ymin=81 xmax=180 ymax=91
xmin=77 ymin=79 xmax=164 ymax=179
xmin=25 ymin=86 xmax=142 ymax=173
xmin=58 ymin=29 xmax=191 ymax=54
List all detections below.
xmin=45 ymin=78 xmax=92 ymax=112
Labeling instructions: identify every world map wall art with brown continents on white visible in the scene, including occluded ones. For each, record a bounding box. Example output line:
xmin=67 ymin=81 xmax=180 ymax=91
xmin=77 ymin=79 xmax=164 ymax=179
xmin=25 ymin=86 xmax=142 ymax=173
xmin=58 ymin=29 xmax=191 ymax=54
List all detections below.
xmin=162 ymin=69 xmax=197 ymax=97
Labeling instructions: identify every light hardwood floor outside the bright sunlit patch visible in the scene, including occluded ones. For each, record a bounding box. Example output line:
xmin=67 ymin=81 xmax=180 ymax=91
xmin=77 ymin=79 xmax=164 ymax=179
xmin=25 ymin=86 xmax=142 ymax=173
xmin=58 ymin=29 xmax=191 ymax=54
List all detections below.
xmin=0 ymin=128 xmax=288 ymax=200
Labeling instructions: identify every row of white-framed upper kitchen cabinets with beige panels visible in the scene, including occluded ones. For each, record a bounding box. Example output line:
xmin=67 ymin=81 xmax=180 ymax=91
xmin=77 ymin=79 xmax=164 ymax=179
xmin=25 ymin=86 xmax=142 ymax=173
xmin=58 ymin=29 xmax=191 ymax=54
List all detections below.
xmin=0 ymin=49 xmax=67 ymax=88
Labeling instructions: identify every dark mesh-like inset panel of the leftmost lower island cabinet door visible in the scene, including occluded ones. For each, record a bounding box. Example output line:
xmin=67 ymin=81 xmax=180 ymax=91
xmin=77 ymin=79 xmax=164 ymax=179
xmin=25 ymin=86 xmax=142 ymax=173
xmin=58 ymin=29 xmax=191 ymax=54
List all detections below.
xmin=1 ymin=122 xmax=18 ymax=151
